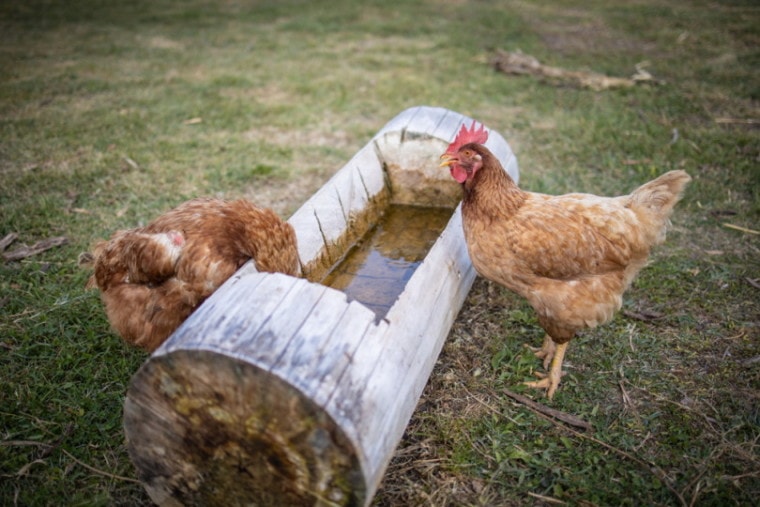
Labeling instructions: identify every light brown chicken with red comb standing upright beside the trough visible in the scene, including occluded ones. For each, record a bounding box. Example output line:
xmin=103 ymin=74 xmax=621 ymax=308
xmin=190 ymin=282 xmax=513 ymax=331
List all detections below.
xmin=441 ymin=122 xmax=691 ymax=399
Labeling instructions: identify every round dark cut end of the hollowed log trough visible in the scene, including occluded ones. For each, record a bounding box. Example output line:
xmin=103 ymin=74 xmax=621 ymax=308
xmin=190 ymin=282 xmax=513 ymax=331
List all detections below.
xmin=124 ymin=350 xmax=367 ymax=506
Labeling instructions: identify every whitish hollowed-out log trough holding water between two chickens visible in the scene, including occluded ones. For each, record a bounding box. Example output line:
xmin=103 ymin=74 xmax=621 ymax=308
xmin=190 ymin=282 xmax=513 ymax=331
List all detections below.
xmin=124 ymin=107 xmax=518 ymax=506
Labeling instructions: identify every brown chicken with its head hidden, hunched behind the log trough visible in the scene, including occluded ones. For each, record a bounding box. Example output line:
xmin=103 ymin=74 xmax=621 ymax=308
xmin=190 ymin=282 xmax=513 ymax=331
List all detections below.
xmin=80 ymin=198 xmax=301 ymax=352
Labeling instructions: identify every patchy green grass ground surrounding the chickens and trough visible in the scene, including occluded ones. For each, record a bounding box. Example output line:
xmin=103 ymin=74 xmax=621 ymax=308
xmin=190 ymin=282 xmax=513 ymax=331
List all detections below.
xmin=0 ymin=0 xmax=760 ymax=506
